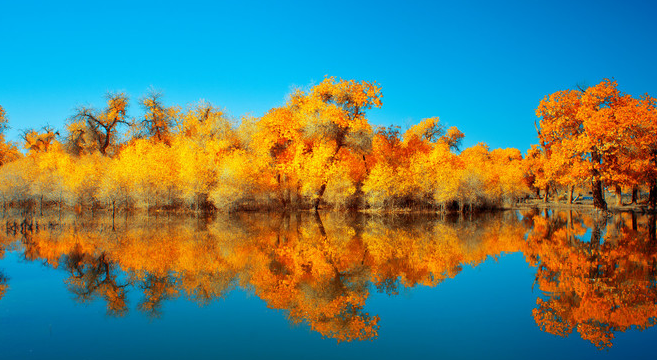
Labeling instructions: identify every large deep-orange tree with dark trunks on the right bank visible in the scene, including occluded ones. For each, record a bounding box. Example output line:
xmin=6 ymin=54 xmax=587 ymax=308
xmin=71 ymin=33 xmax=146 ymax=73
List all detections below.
xmin=536 ymin=79 xmax=657 ymax=209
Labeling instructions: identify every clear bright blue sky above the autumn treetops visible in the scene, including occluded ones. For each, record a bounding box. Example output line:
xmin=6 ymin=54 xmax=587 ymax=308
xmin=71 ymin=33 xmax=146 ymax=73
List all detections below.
xmin=0 ymin=0 xmax=657 ymax=152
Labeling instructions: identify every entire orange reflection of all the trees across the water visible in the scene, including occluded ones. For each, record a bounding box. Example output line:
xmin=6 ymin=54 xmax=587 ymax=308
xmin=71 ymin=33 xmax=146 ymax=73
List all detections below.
xmin=0 ymin=212 xmax=657 ymax=348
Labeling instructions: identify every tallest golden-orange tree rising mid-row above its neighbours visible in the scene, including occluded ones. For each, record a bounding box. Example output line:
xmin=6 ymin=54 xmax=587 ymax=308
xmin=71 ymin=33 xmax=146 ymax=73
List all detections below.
xmin=255 ymin=77 xmax=382 ymax=209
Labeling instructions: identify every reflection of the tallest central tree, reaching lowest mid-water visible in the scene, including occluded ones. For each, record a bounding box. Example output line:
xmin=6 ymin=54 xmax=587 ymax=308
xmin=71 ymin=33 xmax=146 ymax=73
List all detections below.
xmin=243 ymin=215 xmax=379 ymax=341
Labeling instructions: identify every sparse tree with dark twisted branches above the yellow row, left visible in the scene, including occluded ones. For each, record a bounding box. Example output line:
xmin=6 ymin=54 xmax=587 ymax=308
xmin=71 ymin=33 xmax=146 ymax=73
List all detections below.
xmin=67 ymin=93 xmax=129 ymax=155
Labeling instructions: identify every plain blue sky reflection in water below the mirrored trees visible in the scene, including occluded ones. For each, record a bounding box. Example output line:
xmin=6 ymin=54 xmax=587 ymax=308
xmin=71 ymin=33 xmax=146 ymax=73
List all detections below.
xmin=0 ymin=211 xmax=657 ymax=359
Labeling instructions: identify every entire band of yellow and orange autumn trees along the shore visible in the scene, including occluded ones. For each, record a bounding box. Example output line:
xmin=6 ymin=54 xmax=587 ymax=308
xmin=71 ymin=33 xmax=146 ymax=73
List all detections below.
xmin=0 ymin=77 xmax=657 ymax=214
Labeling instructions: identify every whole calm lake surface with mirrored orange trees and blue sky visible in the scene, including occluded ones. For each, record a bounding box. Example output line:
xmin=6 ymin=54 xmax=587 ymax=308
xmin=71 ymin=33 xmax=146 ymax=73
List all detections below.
xmin=0 ymin=211 xmax=657 ymax=359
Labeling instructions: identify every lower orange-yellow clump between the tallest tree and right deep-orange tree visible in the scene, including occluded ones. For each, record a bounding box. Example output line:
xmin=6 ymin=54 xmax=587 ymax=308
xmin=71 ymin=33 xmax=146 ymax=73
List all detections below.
xmin=363 ymin=117 xmax=528 ymax=212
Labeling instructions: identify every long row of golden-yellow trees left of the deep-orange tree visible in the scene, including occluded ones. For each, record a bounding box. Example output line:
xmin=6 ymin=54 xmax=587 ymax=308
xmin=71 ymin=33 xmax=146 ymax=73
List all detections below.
xmin=0 ymin=77 xmax=523 ymax=211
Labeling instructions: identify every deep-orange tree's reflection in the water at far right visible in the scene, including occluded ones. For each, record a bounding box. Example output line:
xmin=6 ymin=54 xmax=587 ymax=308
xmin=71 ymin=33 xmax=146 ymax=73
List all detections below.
xmin=525 ymin=213 xmax=657 ymax=348
